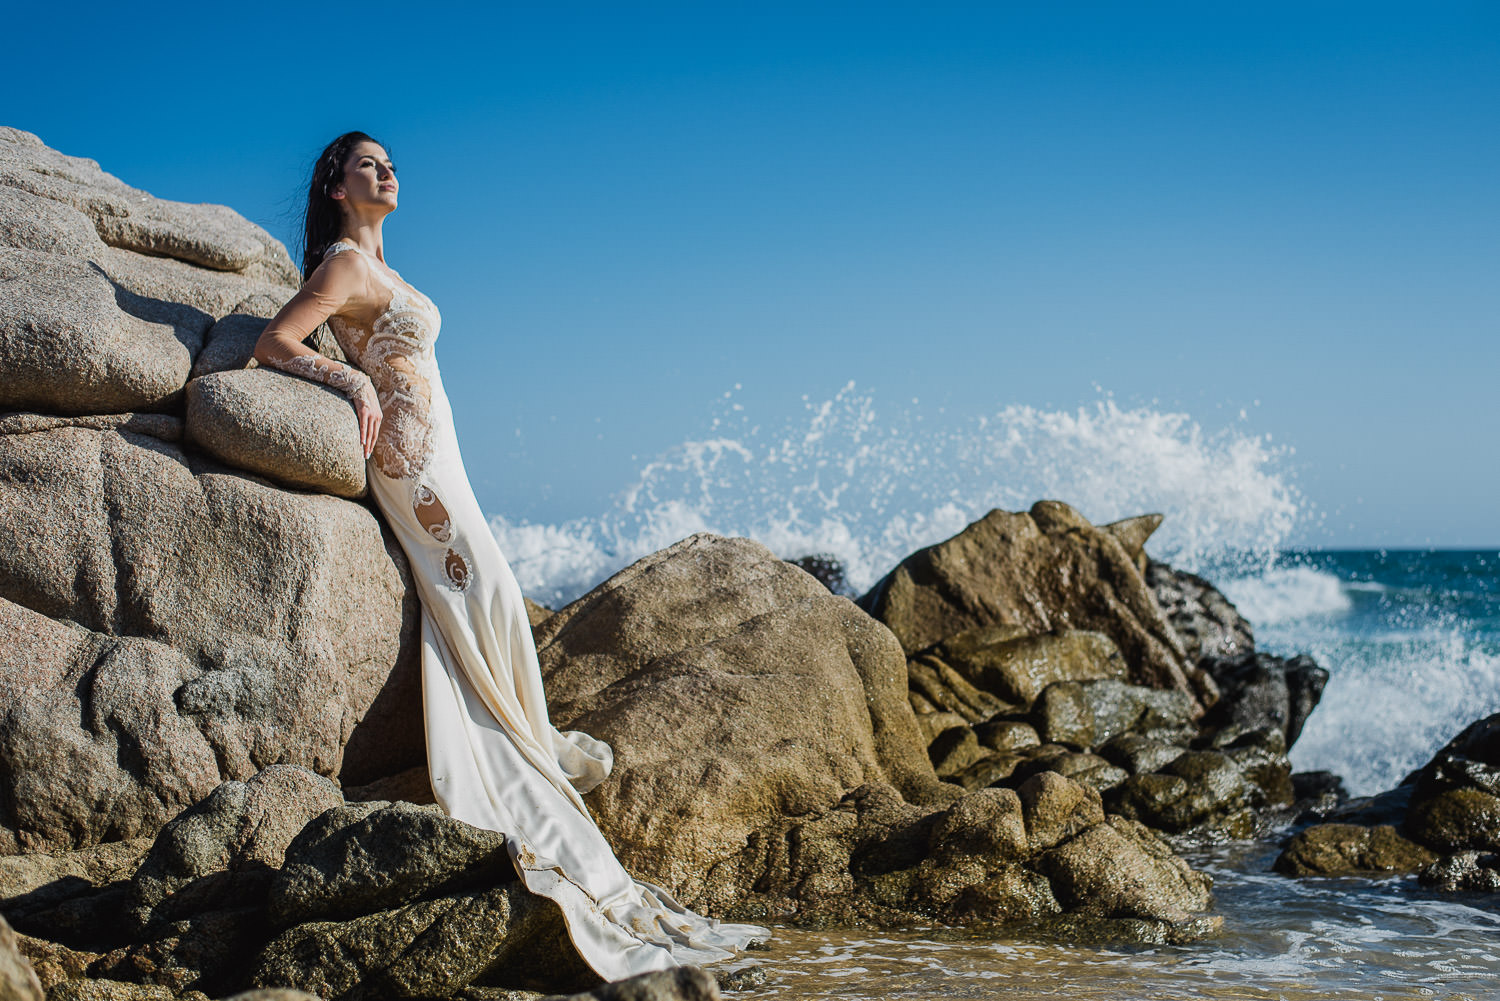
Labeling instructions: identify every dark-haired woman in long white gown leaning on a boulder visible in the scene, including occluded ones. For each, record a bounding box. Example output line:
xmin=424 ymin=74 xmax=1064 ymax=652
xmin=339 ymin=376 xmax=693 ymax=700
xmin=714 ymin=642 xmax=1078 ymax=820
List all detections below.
xmin=255 ymin=132 xmax=768 ymax=980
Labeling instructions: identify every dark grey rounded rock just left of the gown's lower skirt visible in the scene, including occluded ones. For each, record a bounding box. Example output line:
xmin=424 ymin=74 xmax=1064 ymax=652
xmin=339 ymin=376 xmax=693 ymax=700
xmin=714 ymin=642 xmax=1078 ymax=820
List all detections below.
xmin=267 ymin=803 xmax=516 ymax=927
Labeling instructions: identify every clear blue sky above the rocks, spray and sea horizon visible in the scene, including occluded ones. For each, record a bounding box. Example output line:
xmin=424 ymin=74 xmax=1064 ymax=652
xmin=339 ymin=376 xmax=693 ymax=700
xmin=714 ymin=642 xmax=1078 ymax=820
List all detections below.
xmin=0 ymin=2 xmax=1500 ymax=546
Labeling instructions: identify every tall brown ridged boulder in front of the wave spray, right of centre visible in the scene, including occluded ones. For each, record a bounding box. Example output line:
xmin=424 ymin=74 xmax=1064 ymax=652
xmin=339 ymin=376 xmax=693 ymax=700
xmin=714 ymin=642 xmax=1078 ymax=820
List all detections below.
xmin=860 ymin=501 xmax=1214 ymax=711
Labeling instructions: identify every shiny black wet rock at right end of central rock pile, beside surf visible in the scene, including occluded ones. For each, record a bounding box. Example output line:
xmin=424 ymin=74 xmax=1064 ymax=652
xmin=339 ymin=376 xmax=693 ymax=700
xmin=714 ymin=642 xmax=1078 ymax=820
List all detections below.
xmin=1202 ymin=653 xmax=1328 ymax=747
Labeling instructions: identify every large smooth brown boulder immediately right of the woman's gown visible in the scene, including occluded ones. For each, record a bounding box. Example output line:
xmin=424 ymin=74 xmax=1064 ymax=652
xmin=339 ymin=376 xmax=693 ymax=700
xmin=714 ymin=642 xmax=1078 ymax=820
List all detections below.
xmin=537 ymin=534 xmax=960 ymax=909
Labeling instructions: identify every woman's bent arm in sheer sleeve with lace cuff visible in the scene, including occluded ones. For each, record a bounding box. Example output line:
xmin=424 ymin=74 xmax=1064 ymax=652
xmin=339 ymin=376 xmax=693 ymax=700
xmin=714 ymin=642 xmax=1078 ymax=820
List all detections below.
xmin=255 ymin=254 xmax=371 ymax=399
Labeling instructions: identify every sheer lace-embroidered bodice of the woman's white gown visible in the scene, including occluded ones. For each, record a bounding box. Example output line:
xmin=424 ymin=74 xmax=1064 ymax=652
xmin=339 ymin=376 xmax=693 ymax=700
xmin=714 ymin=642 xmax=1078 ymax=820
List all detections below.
xmin=323 ymin=240 xmax=443 ymax=480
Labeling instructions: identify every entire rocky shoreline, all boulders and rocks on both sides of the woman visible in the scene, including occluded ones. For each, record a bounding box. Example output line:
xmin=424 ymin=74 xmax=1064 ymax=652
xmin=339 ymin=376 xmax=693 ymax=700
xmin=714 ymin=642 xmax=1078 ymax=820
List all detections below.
xmin=0 ymin=129 xmax=1500 ymax=1001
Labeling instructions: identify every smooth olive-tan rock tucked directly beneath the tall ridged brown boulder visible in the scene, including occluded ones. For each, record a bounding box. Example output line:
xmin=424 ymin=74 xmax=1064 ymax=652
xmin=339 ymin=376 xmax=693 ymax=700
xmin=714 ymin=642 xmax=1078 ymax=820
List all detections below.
xmin=936 ymin=626 xmax=1127 ymax=711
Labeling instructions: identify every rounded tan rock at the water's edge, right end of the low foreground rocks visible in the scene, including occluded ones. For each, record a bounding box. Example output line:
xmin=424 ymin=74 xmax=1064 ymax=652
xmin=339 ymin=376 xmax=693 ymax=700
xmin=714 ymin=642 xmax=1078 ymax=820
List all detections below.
xmin=1041 ymin=816 xmax=1212 ymax=923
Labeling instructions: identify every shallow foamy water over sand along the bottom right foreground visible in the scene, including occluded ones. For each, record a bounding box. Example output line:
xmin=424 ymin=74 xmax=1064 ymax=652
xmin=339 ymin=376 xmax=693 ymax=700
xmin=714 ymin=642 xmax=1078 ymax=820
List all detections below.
xmin=725 ymin=843 xmax=1500 ymax=1001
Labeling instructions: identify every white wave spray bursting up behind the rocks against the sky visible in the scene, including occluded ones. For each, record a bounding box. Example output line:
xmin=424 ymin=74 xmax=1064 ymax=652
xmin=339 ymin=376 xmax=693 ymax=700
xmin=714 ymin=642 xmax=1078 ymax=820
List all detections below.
xmin=491 ymin=383 xmax=1301 ymax=603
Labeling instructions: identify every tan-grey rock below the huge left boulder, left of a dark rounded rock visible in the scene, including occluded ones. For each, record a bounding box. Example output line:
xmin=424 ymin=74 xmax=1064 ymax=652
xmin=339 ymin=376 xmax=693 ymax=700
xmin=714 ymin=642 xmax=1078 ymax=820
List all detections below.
xmin=128 ymin=765 xmax=344 ymax=932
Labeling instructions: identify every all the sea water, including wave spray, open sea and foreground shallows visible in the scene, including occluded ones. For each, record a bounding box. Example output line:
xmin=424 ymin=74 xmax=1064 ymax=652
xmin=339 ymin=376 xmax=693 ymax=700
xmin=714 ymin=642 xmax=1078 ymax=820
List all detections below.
xmin=492 ymin=386 xmax=1500 ymax=999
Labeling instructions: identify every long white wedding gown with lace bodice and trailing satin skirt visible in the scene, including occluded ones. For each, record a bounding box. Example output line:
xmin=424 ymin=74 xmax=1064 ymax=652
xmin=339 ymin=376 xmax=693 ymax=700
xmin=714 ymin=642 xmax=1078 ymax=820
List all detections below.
xmin=324 ymin=242 xmax=770 ymax=980
